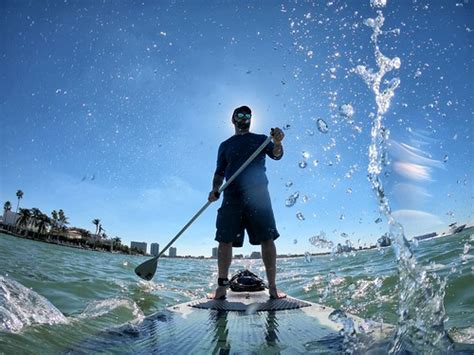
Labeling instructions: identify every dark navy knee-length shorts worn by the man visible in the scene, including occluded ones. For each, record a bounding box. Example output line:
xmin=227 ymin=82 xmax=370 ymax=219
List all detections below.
xmin=215 ymin=185 xmax=280 ymax=248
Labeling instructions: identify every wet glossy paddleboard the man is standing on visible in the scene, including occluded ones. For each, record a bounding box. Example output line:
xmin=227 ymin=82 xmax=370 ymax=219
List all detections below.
xmin=72 ymin=290 xmax=393 ymax=354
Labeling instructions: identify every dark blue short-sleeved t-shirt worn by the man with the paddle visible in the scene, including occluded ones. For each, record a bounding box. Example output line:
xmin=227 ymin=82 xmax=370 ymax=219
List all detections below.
xmin=215 ymin=133 xmax=283 ymax=194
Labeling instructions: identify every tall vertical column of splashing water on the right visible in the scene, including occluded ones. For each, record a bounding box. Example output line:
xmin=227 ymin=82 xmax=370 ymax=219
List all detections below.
xmin=354 ymin=4 xmax=450 ymax=353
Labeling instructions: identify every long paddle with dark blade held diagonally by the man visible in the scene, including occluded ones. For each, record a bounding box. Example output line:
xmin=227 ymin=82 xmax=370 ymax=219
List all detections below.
xmin=135 ymin=134 xmax=273 ymax=281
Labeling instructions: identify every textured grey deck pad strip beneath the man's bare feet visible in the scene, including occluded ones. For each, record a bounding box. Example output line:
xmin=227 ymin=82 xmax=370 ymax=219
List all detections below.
xmin=189 ymin=291 xmax=311 ymax=313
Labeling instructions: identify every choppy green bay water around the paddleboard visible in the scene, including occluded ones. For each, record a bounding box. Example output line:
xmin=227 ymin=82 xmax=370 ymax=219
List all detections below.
xmin=0 ymin=228 xmax=474 ymax=354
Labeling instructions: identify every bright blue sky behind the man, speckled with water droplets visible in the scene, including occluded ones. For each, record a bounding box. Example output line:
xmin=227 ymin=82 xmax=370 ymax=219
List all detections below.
xmin=0 ymin=0 xmax=474 ymax=256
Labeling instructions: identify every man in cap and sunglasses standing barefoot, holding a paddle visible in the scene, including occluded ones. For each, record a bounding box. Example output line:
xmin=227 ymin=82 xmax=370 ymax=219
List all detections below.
xmin=208 ymin=106 xmax=286 ymax=299
